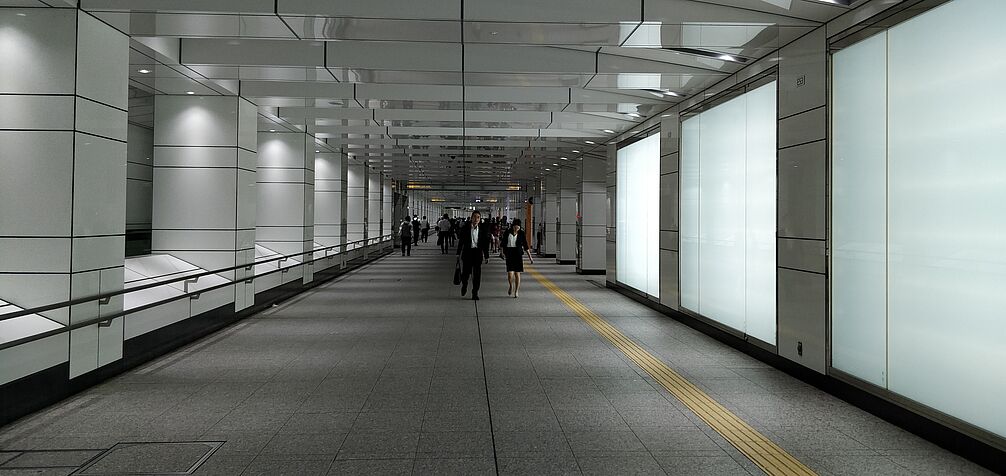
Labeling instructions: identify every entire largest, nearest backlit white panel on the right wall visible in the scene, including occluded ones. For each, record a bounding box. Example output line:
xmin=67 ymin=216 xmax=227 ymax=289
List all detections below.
xmin=833 ymin=0 xmax=1006 ymax=436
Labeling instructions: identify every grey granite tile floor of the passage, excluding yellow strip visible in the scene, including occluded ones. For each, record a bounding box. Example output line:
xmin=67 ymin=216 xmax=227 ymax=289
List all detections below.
xmin=0 ymin=244 xmax=988 ymax=476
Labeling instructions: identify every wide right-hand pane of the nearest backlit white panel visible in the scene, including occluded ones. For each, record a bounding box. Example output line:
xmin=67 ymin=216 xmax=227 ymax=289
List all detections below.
xmin=887 ymin=0 xmax=1006 ymax=436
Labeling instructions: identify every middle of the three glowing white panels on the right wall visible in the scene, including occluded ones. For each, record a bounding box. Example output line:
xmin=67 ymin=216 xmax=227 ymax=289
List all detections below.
xmin=680 ymin=83 xmax=777 ymax=343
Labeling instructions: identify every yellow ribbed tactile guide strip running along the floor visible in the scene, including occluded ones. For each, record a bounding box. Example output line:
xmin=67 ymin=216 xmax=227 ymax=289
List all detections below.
xmin=528 ymin=269 xmax=816 ymax=475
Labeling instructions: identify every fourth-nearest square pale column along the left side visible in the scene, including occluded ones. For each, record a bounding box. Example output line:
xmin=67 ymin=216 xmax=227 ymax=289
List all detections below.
xmin=314 ymin=153 xmax=349 ymax=247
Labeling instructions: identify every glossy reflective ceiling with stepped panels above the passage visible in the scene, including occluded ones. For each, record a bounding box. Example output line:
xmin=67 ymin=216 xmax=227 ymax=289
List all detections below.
xmin=0 ymin=0 xmax=849 ymax=185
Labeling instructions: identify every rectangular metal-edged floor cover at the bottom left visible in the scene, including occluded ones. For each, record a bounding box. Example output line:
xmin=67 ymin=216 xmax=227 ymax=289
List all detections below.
xmin=73 ymin=442 xmax=223 ymax=476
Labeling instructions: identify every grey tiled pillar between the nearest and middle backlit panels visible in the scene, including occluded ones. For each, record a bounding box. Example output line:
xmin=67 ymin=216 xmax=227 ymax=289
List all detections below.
xmin=777 ymin=27 xmax=828 ymax=373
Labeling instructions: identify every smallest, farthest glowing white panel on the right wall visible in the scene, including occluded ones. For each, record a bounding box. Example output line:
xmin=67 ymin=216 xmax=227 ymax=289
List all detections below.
xmin=616 ymin=134 xmax=660 ymax=298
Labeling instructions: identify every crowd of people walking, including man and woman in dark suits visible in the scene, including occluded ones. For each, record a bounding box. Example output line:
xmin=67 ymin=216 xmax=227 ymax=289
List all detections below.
xmin=398 ymin=211 xmax=534 ymax=301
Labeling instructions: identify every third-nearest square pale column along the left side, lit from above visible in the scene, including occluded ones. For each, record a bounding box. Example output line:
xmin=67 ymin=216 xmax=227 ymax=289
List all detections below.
xmin=256 ymin=132 xmax=315 ymax=283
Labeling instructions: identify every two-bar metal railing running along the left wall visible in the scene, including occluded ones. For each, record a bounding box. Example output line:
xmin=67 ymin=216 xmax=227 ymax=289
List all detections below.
xmin=0 ymin=234 xmax=392 ymax=350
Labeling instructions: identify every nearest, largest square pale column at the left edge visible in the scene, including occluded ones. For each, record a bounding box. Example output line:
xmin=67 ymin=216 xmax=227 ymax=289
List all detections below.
xmin=0 ymin=8 xmax=129 ymax=378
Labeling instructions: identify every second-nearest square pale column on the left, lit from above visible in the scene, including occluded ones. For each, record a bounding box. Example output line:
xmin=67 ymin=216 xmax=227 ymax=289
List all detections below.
xmin=151 ymin=96 xmax=259 ymax=314
